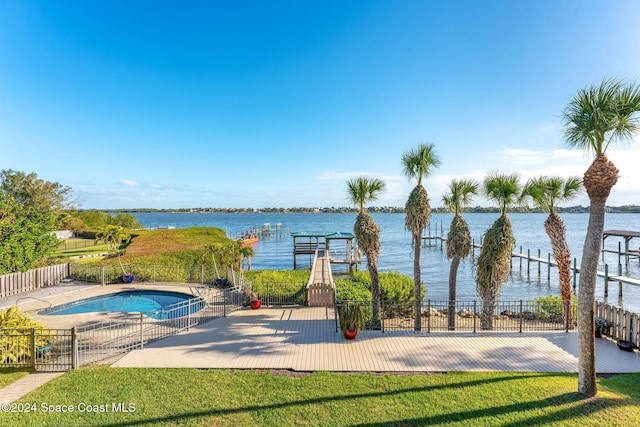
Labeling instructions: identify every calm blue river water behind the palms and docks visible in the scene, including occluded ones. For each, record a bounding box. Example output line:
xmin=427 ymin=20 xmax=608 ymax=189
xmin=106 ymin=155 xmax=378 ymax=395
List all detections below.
xmin=129 ymin=213 xmax=640 ymax=312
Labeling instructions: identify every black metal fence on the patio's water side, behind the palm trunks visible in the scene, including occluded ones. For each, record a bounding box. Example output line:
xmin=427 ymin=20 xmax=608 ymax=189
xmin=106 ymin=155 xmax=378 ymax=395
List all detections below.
xmin=336 ymin=298 xmax=577 ymax=333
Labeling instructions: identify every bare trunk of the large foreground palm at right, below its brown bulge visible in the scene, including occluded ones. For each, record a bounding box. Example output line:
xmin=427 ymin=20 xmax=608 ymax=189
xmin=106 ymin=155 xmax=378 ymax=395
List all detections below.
xmin=578 ymin=198 xmax=606 ymax=397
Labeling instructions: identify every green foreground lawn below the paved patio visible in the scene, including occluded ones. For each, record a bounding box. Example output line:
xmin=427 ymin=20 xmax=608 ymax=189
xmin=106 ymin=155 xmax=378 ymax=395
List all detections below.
xmin=0 ymin=366 xmax=640 ymax=426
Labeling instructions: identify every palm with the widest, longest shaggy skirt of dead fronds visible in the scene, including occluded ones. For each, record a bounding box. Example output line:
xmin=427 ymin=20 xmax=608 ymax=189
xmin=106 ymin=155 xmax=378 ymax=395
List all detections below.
xmin=476 ymin=172 xmax=520 ymax=329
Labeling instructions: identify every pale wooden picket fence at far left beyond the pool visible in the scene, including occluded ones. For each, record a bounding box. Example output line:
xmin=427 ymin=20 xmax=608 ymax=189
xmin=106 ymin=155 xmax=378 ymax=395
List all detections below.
xmin=0 ymin=263 xmax=69 ymax=298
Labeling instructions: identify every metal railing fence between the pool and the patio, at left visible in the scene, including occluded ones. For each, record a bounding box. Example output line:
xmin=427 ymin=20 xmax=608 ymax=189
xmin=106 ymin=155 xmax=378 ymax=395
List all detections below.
xmin=0 ymin=287 xmax=246 ymax=371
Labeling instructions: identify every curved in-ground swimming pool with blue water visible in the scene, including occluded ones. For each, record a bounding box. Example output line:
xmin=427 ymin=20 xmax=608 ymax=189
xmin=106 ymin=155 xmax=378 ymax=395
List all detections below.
xmin=38 ymin=290 xmax=206 ymax=320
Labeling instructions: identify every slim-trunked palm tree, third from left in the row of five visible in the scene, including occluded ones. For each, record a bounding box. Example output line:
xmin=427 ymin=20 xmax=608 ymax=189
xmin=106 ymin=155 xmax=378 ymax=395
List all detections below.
xmin=442 ymin=179 xmax=480 ymax=330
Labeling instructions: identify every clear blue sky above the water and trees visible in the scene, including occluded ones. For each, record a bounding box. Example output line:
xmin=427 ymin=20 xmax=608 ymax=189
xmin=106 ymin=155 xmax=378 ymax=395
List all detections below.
xmin=0 ymin=0 xmax=640 ymax=208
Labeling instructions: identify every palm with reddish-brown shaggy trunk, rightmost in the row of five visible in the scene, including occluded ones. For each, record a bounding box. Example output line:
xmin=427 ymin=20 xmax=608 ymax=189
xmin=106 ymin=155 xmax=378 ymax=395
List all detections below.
xmin=522 ymin=176 xmax=582 ymax=325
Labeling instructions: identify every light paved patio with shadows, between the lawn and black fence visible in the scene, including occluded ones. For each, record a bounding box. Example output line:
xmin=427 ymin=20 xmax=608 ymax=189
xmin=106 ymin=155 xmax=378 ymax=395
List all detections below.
xmin=112 ymin=307 xmax=640 ymax=373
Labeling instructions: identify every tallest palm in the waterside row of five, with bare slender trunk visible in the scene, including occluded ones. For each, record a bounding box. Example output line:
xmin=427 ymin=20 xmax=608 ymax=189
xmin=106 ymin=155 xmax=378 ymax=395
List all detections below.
xmin=402 ymin=144 xmax=440 ymax=331
